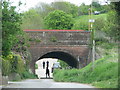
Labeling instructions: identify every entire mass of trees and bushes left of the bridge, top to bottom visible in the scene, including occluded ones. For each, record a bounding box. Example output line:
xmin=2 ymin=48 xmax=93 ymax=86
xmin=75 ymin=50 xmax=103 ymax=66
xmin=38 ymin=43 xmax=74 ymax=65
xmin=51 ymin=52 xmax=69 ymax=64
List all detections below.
xmin=2 ymin=0 xmax=36 ymax=80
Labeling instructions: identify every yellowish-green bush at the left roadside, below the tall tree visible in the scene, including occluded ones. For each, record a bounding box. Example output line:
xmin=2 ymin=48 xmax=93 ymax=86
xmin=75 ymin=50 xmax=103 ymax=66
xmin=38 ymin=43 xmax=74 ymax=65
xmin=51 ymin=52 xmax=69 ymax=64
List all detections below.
xmin=2 ymin=53 xmax=25 ymax=76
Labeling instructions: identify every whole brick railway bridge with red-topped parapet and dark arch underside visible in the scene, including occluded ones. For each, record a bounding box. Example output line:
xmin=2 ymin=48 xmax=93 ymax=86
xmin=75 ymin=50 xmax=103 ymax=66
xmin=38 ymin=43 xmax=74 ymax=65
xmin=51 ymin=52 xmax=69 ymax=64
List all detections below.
xmin=24 ymin=30 xmax=91 ymax=72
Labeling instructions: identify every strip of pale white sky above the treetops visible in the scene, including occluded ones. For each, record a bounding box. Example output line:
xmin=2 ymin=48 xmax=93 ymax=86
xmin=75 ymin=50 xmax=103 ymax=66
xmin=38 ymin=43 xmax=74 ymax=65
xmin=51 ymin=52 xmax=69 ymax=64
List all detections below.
xmin=9 ymin=0 xmax=108 ymax=11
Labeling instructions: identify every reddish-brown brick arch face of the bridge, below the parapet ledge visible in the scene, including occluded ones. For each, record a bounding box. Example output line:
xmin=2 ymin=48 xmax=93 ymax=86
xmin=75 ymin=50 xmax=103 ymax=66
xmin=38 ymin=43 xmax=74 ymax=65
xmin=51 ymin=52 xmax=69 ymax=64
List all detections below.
xmin=29 ymin=46 xmax=89 ymax=73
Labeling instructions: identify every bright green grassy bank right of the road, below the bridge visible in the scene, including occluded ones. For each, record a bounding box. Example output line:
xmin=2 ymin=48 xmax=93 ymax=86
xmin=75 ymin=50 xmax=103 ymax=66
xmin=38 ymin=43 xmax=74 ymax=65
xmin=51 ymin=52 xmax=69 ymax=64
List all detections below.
xmin=54 ymin=55 xmax=118 ymax=88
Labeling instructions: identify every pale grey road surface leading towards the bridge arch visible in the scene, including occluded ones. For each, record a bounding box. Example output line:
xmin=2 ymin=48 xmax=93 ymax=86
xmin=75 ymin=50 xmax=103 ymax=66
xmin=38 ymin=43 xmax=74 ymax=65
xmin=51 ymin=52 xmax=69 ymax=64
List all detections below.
xmin=3 ymin=79 xmax=94 ymax=88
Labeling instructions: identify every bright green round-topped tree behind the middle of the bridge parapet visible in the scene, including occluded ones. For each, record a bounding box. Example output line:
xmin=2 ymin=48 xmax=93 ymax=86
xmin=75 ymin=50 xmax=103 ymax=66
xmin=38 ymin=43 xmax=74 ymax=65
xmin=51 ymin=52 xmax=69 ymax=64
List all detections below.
xmin=44 ymin=10 xmax=73 ymax=29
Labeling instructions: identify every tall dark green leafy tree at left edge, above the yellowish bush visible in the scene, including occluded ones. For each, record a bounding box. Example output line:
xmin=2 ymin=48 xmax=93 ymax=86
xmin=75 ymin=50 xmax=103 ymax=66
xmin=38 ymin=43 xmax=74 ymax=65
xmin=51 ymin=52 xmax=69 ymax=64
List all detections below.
xmin=2 ymin=1 xmax=22 ymax=56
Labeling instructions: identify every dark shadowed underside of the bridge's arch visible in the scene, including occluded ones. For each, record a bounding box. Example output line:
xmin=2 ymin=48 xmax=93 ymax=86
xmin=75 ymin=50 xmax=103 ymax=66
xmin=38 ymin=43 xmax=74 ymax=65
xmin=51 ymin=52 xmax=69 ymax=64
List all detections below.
xmin=39 ymin=51 xmax=78 ymax=68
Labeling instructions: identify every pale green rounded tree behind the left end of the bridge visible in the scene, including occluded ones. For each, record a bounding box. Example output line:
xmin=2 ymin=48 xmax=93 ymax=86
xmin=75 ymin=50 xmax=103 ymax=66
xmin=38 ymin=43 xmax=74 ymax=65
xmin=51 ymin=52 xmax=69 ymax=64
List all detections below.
xmin=21 ymin=9 xmax=44 ymax=29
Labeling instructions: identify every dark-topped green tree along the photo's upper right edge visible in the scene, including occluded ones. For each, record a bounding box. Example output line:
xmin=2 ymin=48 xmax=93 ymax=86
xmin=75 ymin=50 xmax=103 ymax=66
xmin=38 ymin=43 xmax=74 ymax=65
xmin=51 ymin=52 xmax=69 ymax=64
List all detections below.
xmin=103 ymin=2 xmax=120 ymax=40
